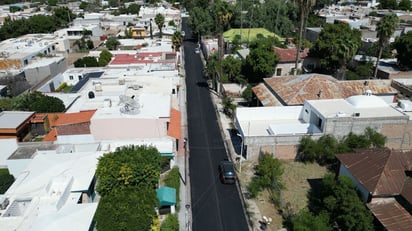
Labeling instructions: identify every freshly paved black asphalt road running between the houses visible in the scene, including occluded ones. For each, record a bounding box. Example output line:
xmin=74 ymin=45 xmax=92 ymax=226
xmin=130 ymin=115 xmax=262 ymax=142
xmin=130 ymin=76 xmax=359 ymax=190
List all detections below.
xmin=182 ymin=20 xmax=249 ymax=231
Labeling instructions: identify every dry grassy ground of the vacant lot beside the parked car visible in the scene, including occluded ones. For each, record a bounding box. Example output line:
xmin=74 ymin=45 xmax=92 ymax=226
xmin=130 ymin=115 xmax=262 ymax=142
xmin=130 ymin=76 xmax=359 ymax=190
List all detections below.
xmin=240 ymin=161 xmax=327 ymax=230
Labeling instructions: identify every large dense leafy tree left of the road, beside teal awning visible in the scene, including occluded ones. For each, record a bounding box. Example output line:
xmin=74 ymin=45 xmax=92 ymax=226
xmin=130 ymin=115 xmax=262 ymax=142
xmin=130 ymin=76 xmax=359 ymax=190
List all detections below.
xmin=95 ymin=145 xmax=161 ymax=231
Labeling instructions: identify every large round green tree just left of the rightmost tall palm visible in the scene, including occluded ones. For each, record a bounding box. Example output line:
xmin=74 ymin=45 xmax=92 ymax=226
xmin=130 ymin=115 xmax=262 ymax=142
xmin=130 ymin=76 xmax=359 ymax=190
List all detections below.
xmin=309 ymin=23 xmax=362 ymax=72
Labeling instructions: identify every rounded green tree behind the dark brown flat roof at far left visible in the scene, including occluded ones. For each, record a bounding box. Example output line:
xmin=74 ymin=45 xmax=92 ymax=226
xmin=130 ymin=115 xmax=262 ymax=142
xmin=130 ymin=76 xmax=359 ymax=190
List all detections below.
xmin=12 ymin=91 xmax=66 ymax=113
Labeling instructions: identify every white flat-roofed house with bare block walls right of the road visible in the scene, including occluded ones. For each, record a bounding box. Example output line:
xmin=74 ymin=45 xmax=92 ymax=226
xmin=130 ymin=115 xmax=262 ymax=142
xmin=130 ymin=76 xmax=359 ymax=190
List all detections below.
xmin=235 ymin=94 xmax=412 ymax=159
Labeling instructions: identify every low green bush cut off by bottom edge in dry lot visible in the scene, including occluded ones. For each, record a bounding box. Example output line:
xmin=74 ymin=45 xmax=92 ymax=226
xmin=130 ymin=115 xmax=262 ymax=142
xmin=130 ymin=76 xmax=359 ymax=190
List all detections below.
xmin=290 ymin=210 xmax=332 ymax=231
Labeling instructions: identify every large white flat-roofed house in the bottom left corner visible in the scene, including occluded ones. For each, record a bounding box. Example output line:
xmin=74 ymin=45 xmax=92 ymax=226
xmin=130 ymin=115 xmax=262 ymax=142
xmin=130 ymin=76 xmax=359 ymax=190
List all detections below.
xmin=0 ymin=144 xmax=103 ymax=230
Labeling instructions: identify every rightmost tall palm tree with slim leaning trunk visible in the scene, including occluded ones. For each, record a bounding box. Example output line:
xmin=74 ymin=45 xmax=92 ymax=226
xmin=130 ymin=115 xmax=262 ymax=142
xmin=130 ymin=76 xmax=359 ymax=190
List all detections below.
xmin=373 ymin=14 xmax=399 ymax=78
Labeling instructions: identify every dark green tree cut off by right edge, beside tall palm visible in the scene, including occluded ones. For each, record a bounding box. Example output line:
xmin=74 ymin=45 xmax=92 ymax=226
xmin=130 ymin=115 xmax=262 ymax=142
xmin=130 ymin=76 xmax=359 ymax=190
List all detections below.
xmin=394 ymin=31 xmax=412 ymax=68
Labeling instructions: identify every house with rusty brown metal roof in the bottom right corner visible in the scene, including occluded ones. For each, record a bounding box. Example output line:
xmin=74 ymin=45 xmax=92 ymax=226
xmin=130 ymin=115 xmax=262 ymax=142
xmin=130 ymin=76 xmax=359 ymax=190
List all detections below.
xmin=336 ymin=148 xmax=412 ymax=231
